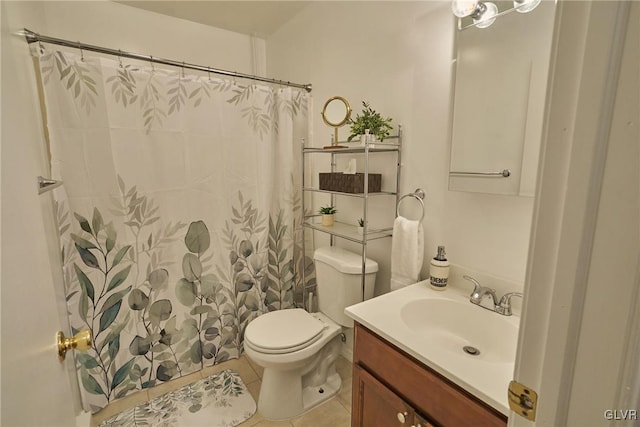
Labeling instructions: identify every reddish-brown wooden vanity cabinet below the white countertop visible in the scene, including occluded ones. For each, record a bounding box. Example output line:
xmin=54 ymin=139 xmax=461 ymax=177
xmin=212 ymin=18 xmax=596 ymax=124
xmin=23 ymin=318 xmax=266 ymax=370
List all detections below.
xmin=351 ymin=323 xmax=507 ymax=427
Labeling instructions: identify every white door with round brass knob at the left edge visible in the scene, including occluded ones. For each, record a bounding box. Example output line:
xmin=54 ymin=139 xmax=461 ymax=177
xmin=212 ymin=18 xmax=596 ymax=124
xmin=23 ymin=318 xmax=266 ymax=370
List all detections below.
xmin=0 ymin=2 xmax=75 ymax=427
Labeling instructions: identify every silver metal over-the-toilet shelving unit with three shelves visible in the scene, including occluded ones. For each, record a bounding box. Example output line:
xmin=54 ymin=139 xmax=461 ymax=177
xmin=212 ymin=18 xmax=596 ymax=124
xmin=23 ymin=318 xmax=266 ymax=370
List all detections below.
xmin=301 ymin=126 xmax=402 ymax=309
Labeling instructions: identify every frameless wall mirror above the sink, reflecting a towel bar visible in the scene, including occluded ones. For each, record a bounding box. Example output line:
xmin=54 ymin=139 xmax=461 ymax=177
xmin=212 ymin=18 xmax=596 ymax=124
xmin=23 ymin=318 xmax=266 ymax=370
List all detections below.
xmin=449 ymin=1 xmax=555 ymax=196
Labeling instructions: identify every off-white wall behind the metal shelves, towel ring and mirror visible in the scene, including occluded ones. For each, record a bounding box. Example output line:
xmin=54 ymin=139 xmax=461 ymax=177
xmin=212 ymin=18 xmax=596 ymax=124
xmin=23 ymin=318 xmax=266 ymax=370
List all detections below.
xmin=267 ymin=1 xmax=533 ymax=293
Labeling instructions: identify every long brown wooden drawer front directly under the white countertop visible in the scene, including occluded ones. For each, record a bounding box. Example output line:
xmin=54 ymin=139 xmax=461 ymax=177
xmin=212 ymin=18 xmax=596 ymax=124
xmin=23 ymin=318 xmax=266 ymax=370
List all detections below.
xmin=353 ymin=324 xmax=507 ymax=427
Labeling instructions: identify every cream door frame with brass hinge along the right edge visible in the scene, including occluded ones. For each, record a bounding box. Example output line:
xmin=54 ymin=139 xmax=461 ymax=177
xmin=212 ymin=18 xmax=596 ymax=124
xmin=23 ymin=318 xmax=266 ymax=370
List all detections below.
xmin=509 ymin=2 xmax=640 ymax=426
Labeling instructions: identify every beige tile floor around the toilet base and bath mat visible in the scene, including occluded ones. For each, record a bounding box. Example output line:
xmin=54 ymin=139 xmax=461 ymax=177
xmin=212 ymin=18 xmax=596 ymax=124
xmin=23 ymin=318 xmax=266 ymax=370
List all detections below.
xmin=91 ymin=356 xmax=351 ymax=427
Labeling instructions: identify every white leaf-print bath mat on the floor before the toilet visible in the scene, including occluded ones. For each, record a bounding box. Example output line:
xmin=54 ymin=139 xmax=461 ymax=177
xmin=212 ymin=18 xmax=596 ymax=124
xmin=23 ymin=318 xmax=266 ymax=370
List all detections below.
xmin=98 ymin=369 xmax=256 ymax=427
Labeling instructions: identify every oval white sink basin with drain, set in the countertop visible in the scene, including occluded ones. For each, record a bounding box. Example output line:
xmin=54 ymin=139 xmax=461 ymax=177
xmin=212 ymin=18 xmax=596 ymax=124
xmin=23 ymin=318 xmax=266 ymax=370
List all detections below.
xmin=400 ymin=298 xmax=518 ymax=363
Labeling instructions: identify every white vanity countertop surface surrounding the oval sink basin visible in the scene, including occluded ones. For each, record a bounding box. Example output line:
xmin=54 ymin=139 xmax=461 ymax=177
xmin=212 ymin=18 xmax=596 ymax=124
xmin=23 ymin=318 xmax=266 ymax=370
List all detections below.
xmin=345 ymin=281 xmax=520 ymax=416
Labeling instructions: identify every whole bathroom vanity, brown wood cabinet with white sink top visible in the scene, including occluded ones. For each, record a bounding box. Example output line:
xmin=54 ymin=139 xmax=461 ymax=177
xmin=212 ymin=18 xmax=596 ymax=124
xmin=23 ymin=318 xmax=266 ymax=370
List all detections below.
xmin=345 ymin=282 xmax=519 ymax=427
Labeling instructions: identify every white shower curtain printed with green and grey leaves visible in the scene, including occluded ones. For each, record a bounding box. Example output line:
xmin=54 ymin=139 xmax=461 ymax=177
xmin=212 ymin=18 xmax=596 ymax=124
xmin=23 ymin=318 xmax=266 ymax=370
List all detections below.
xmin=37 ymin=45 xmax=313 ymax=412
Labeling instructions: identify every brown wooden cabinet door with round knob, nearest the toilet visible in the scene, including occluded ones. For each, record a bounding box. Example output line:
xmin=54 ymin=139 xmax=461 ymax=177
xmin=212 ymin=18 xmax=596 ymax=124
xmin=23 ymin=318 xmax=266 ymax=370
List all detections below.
xmin=351 ymin=365 xmax=414 ymax=427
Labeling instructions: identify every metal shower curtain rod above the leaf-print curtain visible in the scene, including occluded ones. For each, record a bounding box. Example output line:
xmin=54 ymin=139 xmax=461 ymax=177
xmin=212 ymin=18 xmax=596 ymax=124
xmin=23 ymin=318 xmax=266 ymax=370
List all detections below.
xmin=23 ymin=28 xmax=311 ymax=92
